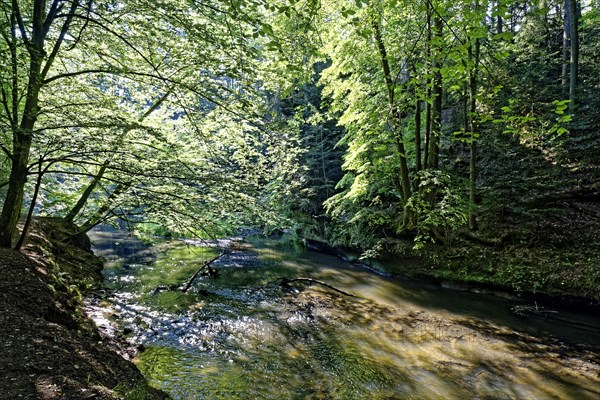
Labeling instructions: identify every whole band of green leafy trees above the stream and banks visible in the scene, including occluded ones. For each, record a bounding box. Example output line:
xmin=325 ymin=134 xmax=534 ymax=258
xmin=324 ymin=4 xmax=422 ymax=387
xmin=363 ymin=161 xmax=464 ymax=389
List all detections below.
xmin=0 ymin=0 xmax=600 ymax=258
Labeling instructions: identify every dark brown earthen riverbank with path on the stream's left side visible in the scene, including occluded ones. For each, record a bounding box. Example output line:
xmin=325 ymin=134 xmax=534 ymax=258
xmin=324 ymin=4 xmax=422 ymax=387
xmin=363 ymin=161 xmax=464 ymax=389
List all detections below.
xmin=0 ymin=219 xmax=166 ymax=400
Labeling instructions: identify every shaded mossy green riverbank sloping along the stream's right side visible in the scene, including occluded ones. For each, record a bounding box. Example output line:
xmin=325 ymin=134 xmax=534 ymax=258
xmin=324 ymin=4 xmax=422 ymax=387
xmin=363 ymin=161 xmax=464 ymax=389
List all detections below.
xmin=305 ymin=197 xmax=600 ymax=306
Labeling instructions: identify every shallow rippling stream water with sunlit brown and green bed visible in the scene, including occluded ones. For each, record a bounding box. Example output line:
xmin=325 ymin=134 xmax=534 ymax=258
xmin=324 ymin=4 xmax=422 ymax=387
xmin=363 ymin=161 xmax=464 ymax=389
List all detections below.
xmin=85 ymin=231 xmax=600 ymax=399
